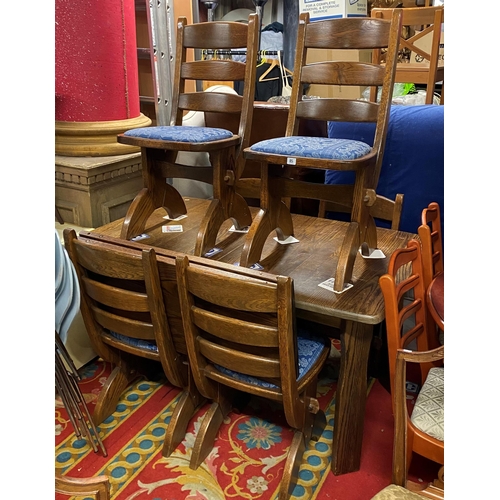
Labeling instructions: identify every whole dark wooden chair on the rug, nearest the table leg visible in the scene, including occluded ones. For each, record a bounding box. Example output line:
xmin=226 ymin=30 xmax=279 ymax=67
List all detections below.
xmin=176 ymin=256 xmax=330 ymax=500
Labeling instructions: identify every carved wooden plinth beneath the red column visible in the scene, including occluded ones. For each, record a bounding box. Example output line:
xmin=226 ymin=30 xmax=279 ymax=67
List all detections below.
xmin=55 ymin=153 xmax=143 ymax=228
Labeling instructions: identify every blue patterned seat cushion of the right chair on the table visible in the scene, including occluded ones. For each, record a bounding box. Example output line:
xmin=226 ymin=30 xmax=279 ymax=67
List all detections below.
xmin=250 ymin=136 xmax=372 ymax=160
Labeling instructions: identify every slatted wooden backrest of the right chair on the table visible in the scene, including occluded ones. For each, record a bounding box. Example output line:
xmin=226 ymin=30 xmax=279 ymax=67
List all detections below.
xmin=286 ymin=11 xmax=401 ymax=184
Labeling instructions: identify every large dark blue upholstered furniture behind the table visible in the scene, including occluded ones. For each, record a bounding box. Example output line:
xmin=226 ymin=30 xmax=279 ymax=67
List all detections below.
xmin=325 ymin=104 xmax=444 ymax=237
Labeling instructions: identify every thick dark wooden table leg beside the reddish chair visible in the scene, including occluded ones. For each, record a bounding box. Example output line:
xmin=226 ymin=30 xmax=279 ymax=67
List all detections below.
xmin=331 ymin=321 xmax=373 ymax=475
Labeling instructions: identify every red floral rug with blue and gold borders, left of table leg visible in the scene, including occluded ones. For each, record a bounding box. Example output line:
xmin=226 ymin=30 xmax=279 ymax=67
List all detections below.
xmin=55 ymin=344 xmax=352 ymax=500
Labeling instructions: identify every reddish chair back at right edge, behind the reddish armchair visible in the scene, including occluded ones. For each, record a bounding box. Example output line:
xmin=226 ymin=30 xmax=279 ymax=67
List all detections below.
xmin=418 ymin=201 xmax=444 ymax=288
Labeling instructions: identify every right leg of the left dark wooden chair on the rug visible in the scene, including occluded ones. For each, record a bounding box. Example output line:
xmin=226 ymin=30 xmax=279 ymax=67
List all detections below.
xmin=162 ymin=390 xmax=206 ymax=457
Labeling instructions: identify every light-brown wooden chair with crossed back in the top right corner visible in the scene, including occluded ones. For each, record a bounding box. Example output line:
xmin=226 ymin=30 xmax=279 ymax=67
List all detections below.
xmin=371 ymin=6 xmax=444 ymax=104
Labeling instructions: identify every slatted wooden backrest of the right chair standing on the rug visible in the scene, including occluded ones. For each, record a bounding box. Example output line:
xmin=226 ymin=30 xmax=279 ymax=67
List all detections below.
xmin=177 ymin=256 xmax=307 ymax=428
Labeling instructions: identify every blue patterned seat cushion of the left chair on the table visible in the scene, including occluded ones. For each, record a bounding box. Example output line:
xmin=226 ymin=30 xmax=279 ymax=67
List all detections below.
xmin=123 ymin=125 xmax=233 ymax=142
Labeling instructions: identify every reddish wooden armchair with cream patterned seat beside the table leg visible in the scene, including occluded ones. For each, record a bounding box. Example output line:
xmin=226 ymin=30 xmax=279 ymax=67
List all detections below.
xmin=379 ymin=240 xmax=444 ymax=485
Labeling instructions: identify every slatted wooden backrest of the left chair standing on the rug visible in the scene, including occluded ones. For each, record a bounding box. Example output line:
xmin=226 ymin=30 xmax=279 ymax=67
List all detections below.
xmin=64 ymin=229 xmax=185 ymax=387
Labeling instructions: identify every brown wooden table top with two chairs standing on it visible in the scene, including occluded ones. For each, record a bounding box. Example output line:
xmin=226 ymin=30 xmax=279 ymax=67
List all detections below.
xmin=93 ymin=198 xmax=418 ymax=325
